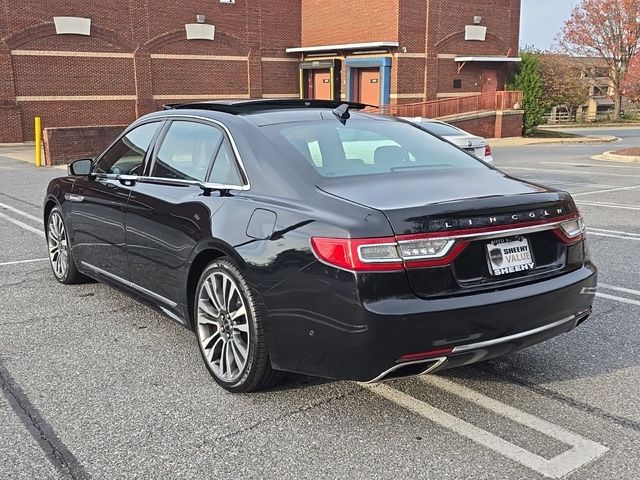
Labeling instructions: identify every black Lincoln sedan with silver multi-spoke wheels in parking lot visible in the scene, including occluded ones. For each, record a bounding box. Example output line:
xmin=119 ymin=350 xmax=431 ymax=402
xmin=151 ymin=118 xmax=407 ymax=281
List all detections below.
xmin=44 ymin=100 xmax=596 ymax=392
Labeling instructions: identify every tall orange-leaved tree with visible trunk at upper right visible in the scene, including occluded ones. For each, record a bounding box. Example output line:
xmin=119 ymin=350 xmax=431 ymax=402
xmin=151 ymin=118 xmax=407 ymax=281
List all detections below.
xmin=558 ymin=0 xmax=640 ymax=120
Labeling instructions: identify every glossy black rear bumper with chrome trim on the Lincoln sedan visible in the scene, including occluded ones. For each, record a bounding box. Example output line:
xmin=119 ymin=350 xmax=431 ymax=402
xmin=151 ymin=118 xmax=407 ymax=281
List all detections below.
xmin=258 ymin=263 xmax=597 ymax=381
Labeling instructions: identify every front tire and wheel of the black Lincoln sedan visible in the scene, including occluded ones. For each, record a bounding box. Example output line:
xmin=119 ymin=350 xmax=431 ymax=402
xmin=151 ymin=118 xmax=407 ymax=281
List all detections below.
xmin=46 ymin=207 xmax=87 ymax=285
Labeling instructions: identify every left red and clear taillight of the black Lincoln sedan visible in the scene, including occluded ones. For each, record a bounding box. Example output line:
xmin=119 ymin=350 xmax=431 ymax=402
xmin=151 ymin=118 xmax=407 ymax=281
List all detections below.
xmin=311 ymin=237 xmax=467 ymax=271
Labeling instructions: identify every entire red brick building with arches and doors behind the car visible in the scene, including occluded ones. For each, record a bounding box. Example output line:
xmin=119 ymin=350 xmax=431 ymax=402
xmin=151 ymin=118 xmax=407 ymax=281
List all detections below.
xmin=0 ymin=0 xmax=520 ymax=142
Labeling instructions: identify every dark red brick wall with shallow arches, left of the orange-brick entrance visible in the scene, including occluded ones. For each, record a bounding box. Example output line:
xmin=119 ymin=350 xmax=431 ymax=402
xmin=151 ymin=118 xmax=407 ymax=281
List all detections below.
xmin=0 ymin=0 xmax=302 ymax=143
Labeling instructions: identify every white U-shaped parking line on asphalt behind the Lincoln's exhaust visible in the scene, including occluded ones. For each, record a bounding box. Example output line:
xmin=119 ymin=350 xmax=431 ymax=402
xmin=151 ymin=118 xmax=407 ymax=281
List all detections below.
xmin=364 ymin=376 xmax=608 ymax=478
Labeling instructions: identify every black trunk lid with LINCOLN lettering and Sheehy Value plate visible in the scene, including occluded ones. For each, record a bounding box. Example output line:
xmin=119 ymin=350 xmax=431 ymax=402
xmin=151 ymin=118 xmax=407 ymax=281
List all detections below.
xmin=318 ymin=169 xmax=581 ymax=297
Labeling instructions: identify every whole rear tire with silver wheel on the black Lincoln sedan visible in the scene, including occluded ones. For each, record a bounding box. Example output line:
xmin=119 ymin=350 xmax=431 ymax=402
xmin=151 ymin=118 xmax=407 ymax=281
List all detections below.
xmin=193 ymin=258 xmax=282 ymax=393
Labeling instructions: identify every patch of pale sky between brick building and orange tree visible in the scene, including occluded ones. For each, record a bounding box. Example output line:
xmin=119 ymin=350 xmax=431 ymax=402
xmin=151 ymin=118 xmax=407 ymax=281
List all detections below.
xmin=520 ymin=0 xmax=578 ymax=50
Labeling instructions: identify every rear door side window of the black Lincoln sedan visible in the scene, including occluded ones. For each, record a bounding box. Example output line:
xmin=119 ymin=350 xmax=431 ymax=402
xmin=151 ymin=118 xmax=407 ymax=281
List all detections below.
xmin=151 ymin=121 xmax=224 ymax=181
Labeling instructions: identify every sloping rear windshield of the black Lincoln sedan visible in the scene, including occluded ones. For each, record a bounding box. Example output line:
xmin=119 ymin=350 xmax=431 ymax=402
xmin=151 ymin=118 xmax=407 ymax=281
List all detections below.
xmin=264 ymin=120 xmax=487 ymax=177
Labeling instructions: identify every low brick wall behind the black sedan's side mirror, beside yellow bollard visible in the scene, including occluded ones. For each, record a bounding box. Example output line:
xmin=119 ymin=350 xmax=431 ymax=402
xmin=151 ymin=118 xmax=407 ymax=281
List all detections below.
xmin=43 ymin=125 xmax=126 ymax=166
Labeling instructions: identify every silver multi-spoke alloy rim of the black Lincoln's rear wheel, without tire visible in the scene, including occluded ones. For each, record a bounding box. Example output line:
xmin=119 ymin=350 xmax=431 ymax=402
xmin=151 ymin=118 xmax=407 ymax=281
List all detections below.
xmin=197 ymin=271 xmax=250 ymax=382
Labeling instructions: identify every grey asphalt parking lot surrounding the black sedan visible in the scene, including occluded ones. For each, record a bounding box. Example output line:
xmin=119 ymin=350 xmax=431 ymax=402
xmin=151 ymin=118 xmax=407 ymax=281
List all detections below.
xmin=0 ymin=128 xmax=640 ymax=480
